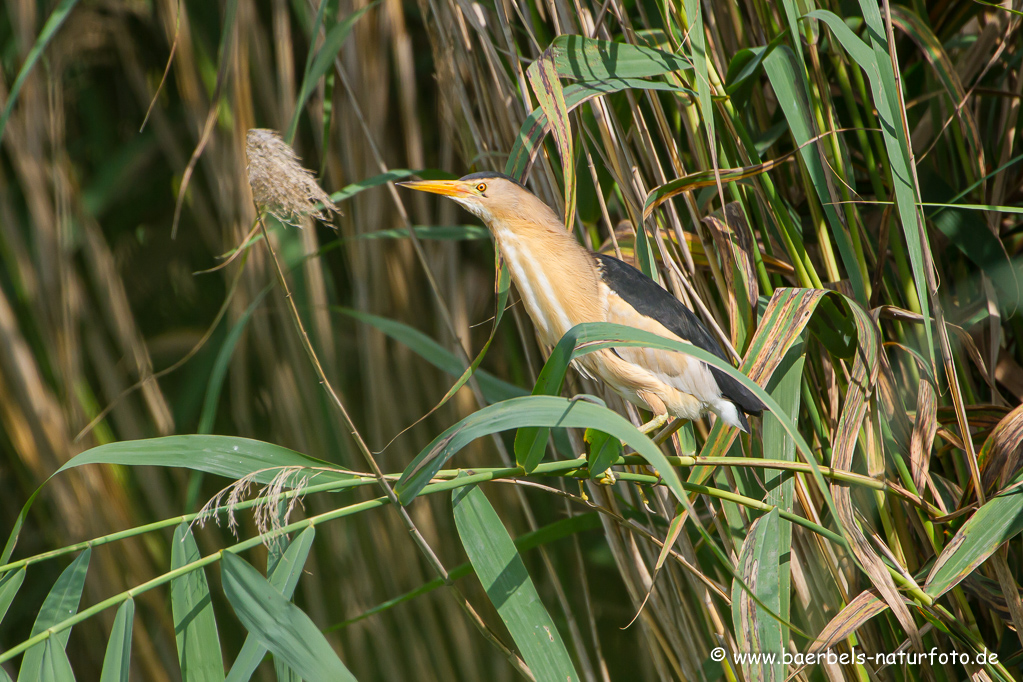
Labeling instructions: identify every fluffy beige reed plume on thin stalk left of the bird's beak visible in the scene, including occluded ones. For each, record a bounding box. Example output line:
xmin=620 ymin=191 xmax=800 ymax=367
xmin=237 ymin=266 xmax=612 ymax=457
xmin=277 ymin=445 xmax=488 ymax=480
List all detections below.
xmin=246 ymin=128 xmax=340 ymax=227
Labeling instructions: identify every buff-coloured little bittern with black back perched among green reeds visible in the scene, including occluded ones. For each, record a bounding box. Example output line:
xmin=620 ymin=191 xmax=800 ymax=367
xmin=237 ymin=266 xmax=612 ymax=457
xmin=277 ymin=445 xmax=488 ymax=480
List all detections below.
xmin=397 ymin=172 xmax=765 ymax=433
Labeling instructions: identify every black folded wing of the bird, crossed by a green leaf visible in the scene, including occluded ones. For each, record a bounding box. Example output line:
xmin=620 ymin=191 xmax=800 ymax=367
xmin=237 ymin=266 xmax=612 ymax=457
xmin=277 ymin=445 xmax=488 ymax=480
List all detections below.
xmin=593 ymin=254 xmax=765 ymax=414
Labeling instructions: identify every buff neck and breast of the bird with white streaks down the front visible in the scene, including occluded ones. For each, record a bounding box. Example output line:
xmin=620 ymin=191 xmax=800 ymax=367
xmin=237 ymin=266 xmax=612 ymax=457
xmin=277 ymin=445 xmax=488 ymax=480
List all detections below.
xmin=490 ymin=209 xmax=607 ymax=346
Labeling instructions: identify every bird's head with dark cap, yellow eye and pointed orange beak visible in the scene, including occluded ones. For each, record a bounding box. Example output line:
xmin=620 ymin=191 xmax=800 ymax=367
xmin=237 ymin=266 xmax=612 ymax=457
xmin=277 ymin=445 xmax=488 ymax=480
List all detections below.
xmin=397 ymin=173 xmax=531 ymax=225
